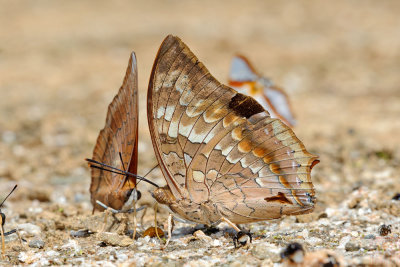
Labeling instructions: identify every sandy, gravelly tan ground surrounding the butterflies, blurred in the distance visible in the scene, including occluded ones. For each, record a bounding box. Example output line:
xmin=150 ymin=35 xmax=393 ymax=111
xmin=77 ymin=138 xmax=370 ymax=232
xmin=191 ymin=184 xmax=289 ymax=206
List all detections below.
xmin=0 ymin=0 xmax=400 ymax=266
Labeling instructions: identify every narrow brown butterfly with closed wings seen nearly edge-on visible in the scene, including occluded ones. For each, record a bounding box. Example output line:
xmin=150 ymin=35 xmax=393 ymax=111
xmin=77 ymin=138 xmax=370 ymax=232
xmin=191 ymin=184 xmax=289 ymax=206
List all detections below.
xmin=90 ymin=53 xmax=138 ymax=210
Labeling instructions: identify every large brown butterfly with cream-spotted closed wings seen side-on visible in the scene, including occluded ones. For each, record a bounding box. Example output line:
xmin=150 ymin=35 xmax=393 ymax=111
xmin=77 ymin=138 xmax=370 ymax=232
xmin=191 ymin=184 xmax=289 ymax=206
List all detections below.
xmin=147 ymin=35 xmax=319 ymax=225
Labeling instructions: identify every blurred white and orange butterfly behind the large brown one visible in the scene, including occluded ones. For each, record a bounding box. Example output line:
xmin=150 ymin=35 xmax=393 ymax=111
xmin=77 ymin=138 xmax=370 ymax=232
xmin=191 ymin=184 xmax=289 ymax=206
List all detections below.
xmin=229 ymin=55 xmax=296 ymax=127
